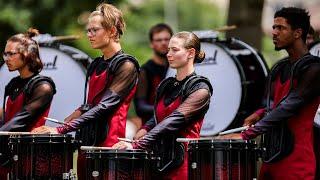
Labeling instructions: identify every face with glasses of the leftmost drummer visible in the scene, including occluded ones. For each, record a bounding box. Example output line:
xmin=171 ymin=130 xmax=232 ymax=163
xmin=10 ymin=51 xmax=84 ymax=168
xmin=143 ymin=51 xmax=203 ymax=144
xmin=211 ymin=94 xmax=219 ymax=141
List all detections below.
xmin=3 ymin=41 xmax=26 ymax=71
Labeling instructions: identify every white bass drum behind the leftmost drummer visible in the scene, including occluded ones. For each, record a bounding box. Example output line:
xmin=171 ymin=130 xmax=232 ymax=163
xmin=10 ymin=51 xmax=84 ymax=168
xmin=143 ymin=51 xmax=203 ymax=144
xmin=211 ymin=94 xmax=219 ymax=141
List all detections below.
xmin=0 ymin=44 xmax=92 ymax=124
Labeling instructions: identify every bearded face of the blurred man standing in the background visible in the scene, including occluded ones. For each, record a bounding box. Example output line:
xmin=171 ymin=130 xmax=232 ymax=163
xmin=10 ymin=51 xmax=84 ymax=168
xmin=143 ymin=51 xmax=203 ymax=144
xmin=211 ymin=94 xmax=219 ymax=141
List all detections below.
xmin=150 ymin=30 xmax=171 ymax=57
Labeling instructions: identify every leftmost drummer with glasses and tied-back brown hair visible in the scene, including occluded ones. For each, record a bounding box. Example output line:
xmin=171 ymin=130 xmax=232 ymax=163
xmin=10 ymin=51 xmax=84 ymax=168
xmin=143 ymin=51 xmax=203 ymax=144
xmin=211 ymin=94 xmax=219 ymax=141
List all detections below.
xmin=0 ymin=28 xmax=56 ymax=179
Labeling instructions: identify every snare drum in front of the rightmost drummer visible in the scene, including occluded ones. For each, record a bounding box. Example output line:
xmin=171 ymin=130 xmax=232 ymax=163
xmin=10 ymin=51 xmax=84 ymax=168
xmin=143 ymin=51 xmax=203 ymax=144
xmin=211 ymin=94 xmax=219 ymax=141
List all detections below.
xmin=188 ymin=139 xmax=257 ymax=180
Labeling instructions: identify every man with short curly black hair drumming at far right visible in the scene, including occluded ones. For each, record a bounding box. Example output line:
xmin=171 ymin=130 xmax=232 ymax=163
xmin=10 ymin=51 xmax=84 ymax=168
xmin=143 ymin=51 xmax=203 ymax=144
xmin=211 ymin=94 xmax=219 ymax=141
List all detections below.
xmin=224 ymin=7 xmax=320 ymax=180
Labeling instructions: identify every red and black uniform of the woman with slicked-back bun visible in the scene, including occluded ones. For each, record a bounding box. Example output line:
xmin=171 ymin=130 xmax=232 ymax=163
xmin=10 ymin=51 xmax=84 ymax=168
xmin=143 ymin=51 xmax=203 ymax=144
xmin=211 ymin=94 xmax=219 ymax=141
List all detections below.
xmin=133 ymin=73 xmax=212 ymax=179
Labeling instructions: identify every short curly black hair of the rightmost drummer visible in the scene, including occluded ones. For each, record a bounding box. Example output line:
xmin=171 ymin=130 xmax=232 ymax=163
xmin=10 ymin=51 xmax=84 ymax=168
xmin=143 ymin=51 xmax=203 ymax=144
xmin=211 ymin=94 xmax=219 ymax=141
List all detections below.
xmin=274 ymin=7 xmax=310 ymax=42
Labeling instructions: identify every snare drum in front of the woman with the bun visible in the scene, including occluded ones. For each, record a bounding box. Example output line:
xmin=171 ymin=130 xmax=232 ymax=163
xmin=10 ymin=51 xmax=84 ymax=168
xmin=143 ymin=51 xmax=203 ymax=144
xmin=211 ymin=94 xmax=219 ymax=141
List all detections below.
xmin=81 ymin=146 xmax=150 ymax=180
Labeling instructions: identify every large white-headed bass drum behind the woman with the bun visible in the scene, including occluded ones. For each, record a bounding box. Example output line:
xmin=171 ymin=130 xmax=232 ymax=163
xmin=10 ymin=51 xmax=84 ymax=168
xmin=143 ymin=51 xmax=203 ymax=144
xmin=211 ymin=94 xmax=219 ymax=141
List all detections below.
xmin=167 ymin=37 xmax=268 ymax=136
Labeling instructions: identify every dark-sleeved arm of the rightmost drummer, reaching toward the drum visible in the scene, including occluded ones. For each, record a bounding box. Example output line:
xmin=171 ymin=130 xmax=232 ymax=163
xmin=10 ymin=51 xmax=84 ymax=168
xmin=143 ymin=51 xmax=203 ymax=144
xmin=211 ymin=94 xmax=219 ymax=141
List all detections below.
xmin=242 ymin=64 xmax=320 ymax=139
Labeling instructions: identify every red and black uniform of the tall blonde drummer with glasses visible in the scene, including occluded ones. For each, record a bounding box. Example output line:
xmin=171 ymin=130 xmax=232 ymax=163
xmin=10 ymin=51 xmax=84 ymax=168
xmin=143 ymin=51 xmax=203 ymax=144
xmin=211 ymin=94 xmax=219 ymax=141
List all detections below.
xmin=57 ymin=51 xmax=139 ymax=178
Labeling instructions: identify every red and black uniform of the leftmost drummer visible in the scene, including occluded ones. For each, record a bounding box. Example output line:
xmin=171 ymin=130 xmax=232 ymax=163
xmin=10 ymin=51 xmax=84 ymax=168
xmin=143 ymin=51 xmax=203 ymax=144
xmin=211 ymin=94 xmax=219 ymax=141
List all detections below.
xmin=0 ymin=74 xmax=56 ymax=179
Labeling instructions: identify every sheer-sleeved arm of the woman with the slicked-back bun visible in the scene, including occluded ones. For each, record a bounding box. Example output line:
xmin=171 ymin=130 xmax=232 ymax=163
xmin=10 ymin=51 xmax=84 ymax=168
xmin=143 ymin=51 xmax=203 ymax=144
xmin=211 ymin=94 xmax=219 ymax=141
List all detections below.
xmin=133 ymin=88 xmax=210 ymax=149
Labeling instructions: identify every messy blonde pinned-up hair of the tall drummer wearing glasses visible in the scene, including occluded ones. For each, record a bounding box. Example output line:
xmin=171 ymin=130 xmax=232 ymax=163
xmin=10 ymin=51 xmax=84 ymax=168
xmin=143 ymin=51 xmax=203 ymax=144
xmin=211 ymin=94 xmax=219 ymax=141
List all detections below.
xmin=89 ymin=3 xmax=126 ymax=40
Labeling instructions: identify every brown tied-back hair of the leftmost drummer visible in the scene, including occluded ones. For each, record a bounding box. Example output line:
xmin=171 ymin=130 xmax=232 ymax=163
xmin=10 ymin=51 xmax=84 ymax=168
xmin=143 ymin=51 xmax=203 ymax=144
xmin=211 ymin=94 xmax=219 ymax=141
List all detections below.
xmin=7 ymin=28 xmax=43 ymax=73
